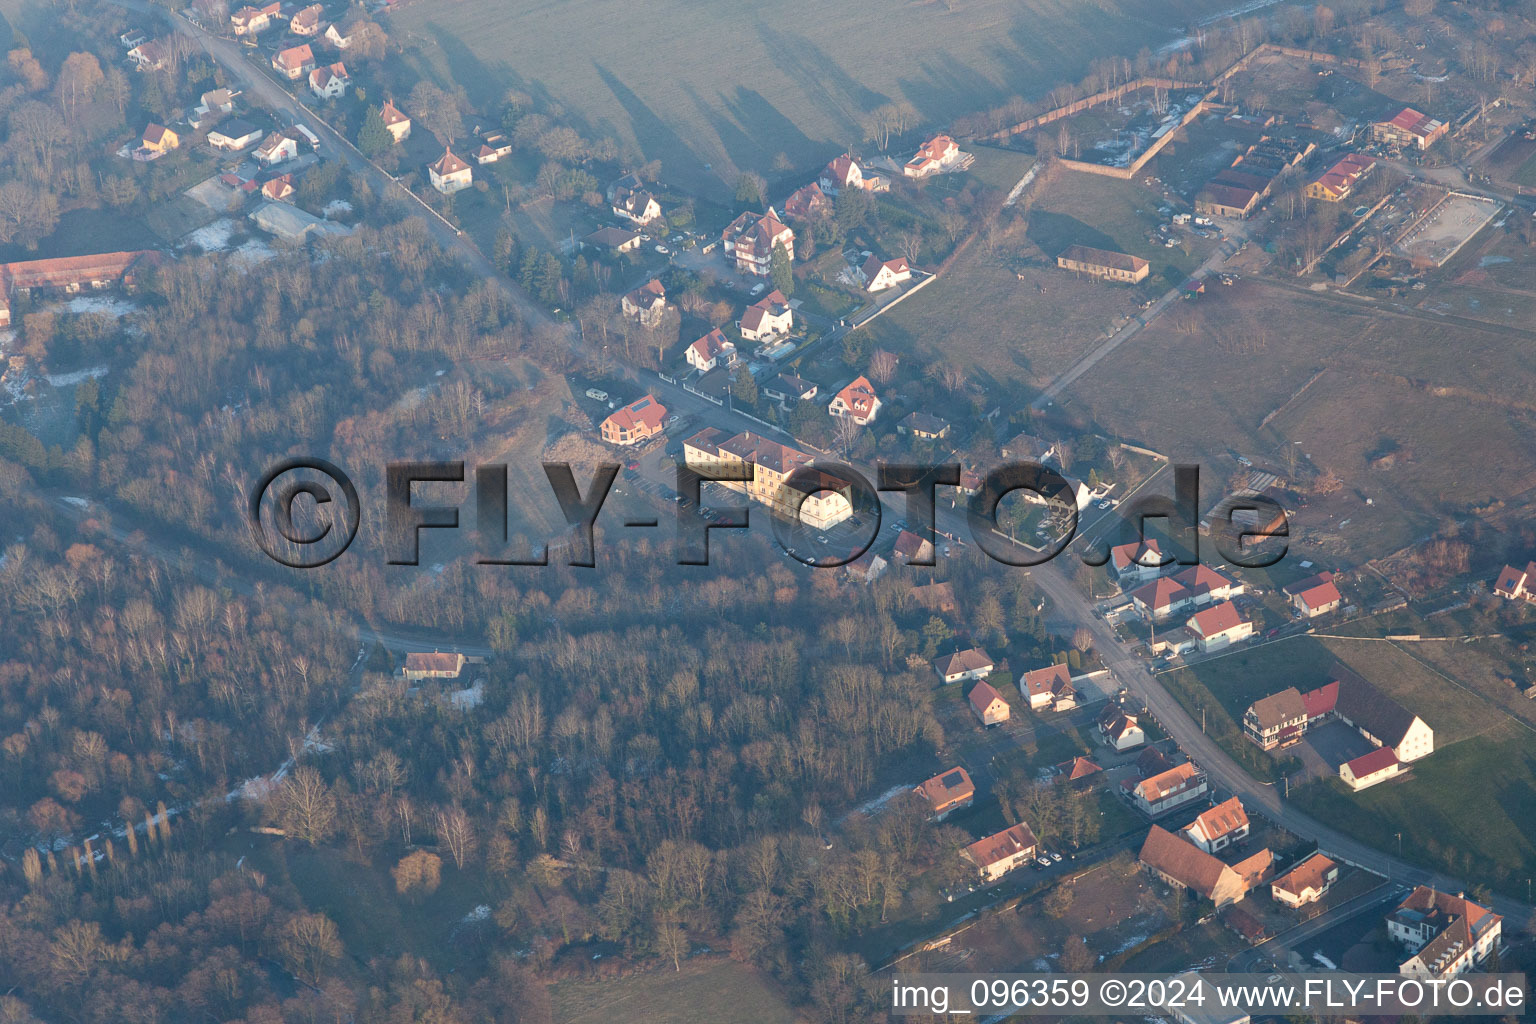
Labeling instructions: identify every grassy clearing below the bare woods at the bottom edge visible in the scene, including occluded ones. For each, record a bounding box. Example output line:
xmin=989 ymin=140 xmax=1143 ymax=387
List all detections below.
xmin=550 ymin=958 xmax=796 ymax=1024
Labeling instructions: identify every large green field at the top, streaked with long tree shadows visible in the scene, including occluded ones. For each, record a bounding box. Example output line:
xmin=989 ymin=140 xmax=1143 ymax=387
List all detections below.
xmin=387 ymin=0 xmax=1284 ymax=190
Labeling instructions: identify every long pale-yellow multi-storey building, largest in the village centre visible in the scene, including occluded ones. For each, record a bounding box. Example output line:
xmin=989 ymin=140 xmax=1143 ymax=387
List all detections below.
xmin=682 ymin=427 xmax=852 ymax=530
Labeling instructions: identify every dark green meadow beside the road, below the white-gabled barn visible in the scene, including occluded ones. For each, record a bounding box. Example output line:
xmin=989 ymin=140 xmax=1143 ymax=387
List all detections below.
xmin=1290 ymin=723 xmax=1536 ymax=898
